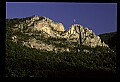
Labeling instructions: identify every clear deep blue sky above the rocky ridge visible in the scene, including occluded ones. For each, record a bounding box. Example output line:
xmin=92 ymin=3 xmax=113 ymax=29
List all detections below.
xmin=6 ymin=2 xmax=117 ymax=35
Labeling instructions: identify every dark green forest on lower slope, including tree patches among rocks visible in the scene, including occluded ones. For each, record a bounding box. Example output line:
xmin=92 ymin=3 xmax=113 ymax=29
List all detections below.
xmin=5 ymin=18 xmax=116 ymax=78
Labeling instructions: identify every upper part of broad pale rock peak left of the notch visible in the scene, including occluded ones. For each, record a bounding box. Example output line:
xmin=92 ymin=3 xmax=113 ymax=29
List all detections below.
xmin=14 ymin=15 xmax=64 ymax=32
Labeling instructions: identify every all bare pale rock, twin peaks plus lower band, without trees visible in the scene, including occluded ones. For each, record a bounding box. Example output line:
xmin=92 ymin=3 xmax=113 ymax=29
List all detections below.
xmin=12 ymin=16 xmax=108 ymax=51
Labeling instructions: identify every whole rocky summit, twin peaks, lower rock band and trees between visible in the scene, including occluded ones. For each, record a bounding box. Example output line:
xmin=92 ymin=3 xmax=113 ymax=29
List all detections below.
xmin=11 ymin=15 xmax=108 ymax=52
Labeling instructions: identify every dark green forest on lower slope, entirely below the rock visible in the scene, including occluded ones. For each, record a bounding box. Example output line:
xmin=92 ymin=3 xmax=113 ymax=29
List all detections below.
xmin=5 ymin=42 xmax=116 ymax=77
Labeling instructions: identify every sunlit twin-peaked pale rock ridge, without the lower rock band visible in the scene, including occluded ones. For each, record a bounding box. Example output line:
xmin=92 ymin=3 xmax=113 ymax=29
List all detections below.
xmin=12 ymin=15 xmax=108 ymax=47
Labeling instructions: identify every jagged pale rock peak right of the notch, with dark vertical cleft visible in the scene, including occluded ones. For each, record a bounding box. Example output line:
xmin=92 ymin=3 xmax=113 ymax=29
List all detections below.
xmin=66 ymin=24 xmax=108 ymax=47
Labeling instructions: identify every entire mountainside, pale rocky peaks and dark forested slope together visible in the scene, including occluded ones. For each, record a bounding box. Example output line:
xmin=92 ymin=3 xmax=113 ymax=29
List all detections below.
xmin=5 ymin=16 xmax=116 ymax=78
